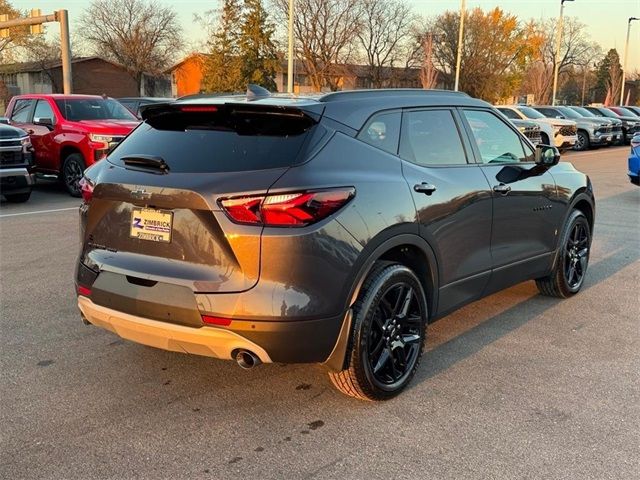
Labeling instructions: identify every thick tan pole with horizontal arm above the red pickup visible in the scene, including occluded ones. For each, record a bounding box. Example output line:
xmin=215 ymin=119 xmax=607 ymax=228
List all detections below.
xmin=0 ymin=9 xmax=73 ymax=94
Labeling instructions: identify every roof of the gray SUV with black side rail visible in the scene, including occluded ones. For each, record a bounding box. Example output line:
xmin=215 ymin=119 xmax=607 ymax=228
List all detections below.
xmin=172 ymin=88 xmax=491 ymax=130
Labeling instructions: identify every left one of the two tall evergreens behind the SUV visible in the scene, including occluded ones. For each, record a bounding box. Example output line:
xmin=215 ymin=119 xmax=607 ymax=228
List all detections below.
xmin=202 ymin=0 xmax=246 ymax=92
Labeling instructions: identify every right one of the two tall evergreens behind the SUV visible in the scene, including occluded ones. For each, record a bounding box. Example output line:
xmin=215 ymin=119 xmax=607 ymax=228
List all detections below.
xmin=240 ymin=0 xmax=278 ymax=91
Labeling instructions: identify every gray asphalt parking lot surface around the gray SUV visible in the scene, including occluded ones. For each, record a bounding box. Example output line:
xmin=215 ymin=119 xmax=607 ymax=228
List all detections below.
xmin=0 ymin=147 xmax=640 ymax=480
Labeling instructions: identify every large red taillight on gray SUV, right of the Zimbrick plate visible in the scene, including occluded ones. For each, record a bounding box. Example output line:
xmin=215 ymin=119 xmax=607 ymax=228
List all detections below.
xmin=219 ymin=187 xmax=355 ymax=227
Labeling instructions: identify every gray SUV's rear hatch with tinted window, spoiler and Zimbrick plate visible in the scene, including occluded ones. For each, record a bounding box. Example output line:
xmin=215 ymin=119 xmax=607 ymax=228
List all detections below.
xmin=82 ymin=103 xmax=321 ymax=293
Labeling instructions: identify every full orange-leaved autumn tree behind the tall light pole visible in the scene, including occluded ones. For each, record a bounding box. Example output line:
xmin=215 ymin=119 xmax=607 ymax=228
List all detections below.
xmin=433 ymin=8 xmax=539 ymax=102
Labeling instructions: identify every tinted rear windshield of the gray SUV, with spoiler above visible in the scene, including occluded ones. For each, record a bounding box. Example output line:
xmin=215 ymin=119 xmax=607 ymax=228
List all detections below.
xmin=109 ymin=107 xmax=315 ymax=173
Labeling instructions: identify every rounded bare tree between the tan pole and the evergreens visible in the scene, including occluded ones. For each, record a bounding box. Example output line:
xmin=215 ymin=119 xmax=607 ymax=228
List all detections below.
xmin=80 ymin=0 xmax=182 ymax=94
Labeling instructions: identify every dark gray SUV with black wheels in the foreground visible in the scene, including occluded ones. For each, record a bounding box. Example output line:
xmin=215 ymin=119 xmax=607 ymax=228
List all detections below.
xmin=76 ymin=87 xmax=595 ymax=400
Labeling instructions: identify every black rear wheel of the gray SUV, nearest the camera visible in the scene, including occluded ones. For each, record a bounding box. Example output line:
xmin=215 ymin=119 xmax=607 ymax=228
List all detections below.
xmin=329 ymin=262 xmax=428 ymax=400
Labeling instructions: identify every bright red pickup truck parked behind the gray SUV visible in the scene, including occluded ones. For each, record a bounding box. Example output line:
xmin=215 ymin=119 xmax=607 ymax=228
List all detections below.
xmin=6 ymin=94 xmax=140 ymax=197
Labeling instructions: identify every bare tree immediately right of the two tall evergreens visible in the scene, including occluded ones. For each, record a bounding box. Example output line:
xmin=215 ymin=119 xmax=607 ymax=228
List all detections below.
xmin=273 ymin=0 xmax=362 ymax=91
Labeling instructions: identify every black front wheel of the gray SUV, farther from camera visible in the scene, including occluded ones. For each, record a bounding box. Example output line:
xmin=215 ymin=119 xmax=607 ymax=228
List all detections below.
xmin=536 ymin=210 xmax=591 ymax=298
